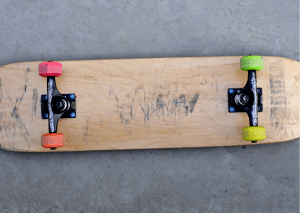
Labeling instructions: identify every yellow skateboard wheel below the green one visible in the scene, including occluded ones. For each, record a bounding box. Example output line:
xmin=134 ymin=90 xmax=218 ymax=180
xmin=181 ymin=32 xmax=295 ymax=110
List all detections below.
xmin=243 ymin=126 xmax=266 ymax=141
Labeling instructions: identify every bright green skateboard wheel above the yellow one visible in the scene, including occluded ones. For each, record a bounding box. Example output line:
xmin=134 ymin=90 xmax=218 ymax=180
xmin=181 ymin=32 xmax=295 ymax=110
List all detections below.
xmin=240 ymin=55 xmax=264 ymax=71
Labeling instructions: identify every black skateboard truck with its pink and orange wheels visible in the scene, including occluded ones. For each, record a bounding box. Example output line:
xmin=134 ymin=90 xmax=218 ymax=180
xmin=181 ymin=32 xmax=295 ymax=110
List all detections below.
xmin=39 ymin=61 xmax=76 ymax=150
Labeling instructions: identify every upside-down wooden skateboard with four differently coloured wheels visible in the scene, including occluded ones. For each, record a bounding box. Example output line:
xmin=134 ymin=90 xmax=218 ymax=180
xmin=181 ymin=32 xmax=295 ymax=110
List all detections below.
xmin=0 ymin=55 xmax=300 ymax=152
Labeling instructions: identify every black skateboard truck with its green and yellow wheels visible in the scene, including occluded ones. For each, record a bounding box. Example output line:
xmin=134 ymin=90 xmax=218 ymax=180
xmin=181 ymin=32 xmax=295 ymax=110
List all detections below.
xmin=228 ymin=55 xmax=266 ymax=143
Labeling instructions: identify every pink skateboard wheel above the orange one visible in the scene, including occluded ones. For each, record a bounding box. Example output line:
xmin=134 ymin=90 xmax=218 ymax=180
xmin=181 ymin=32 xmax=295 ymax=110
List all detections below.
xmin=39 ymin=61 xmax=62 ymax=77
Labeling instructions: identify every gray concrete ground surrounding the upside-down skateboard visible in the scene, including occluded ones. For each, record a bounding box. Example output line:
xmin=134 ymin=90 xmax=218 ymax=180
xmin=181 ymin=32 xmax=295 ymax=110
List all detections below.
xmin=0 ymin=0 xmax=299 ymax=213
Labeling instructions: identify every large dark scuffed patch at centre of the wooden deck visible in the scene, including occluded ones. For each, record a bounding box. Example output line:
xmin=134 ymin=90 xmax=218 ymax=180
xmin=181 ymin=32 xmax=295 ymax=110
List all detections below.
xmin=109 ymin=85 xmax=200 ymax=124
